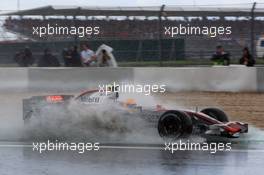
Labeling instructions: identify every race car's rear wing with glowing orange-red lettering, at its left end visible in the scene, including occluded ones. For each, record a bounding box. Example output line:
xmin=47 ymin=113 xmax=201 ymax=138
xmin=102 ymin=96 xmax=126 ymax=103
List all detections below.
xmin=22 ymin=95 xmax=74 ymax=121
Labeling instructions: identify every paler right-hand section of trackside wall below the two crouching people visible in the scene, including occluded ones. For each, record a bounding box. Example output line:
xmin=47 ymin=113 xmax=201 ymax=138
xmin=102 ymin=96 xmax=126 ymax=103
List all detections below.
xmin=134 ymin=67 xmax=260 ymax=92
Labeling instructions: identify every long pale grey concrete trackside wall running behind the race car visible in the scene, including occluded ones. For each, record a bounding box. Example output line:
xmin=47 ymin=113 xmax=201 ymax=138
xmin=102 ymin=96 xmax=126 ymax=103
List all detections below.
xmin=0 ymin=67 xmax=264 ymax=92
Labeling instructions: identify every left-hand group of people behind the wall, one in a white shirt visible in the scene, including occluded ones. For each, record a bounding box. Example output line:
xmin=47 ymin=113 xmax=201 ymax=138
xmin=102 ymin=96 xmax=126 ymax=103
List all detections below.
xmin=14 ymin=43 xmax=117 ymax=67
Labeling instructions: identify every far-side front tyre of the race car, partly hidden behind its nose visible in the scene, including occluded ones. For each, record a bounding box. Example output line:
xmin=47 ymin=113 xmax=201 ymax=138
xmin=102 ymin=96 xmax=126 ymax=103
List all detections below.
xmin=201 ymin=108 xmax=229 ymax=122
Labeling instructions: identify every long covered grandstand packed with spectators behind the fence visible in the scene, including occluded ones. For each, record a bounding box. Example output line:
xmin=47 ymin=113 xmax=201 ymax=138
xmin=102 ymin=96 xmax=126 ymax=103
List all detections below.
xmin=2 ymin=5 xmax=264 ymax=65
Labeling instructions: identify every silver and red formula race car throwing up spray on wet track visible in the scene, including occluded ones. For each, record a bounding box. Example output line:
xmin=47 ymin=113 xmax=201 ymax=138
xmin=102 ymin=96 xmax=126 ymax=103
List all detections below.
xmin=23 ymin=90 xmax=248 ymax=139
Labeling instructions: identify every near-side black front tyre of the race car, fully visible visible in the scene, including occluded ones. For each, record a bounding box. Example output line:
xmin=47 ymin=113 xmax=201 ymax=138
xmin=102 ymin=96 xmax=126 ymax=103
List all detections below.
xmin=158 ymin=110 xmax=193 ymax=139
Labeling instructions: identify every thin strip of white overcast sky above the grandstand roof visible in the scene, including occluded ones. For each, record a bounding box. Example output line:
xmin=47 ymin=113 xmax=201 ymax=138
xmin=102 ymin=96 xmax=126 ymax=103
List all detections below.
xmin=0 ymin=0 xmax=264 ymax=10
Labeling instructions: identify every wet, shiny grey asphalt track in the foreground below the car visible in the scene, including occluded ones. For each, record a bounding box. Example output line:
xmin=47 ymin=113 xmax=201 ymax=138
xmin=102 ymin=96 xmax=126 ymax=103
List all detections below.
xmin=0 ymin=143 xmax=264 ymax=175
